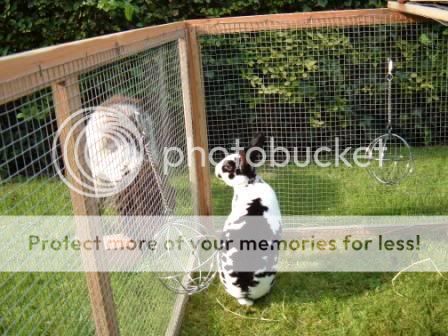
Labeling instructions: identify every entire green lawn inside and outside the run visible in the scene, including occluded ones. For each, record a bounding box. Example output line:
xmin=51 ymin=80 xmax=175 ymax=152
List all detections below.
xmin=0 ymin=147 xmax=448 ymax=336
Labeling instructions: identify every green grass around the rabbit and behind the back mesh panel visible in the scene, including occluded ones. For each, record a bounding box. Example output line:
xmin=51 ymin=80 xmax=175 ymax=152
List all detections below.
xmin=181 ymin=147 xmax=448 ymax=336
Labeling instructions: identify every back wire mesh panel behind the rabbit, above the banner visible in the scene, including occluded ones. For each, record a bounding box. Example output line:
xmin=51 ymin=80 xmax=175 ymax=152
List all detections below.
xmin=200 ymin=13 xmax=448 ymax=219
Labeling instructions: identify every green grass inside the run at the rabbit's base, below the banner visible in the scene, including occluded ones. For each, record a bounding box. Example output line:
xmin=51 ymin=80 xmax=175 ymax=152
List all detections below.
xmin=181 ymin=273 xmax=448 ymax=336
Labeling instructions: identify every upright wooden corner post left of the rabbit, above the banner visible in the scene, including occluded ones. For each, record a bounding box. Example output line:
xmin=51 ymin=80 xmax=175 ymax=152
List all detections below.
xmin=179 ymin=25 xmax=212 ymax=216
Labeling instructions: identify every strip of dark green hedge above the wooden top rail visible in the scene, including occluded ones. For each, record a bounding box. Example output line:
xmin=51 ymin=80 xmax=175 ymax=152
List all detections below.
xmin=0 ymin=0 xmax=385 ymax=55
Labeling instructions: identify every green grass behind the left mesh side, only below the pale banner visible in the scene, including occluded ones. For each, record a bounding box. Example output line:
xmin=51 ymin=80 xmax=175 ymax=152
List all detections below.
xmin=0 ymin=273 xmax=175 ymax=336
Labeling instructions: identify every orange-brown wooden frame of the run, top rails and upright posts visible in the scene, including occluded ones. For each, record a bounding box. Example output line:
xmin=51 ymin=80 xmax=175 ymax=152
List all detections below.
xmin=0 ymin=7 xmax=434 ymax=335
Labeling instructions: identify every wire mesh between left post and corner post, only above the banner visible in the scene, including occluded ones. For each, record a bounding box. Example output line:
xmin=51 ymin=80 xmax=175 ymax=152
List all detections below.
xmin=80 ymin=42 xmax=192 ymax=216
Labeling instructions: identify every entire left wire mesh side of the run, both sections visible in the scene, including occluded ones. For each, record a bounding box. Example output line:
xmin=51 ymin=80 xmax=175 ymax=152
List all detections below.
xmin=0 ymin=33 xmax=194 ymax=335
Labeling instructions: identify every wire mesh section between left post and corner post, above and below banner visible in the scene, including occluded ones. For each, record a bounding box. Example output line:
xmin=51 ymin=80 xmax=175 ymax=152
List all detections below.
xmin=80 ymin=42 xmax=193 ymax=335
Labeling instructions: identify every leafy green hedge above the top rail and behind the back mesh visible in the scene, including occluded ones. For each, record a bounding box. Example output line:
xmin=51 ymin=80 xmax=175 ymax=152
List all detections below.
xmin=4 ymin=0 xmax=448 ymax=181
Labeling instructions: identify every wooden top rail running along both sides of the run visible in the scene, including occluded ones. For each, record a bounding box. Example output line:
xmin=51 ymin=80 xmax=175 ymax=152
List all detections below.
xmin=0 ymin=9 xmax=428 ymax=86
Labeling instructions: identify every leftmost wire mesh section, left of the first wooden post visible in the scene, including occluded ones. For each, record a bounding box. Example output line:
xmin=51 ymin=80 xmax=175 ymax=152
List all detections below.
xmin=0 ymin=88 xmax=94 ymax=335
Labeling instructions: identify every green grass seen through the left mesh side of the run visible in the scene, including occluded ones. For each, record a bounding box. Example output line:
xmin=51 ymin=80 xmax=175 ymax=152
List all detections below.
xmin=0 ymin=178 xmax=178 ymax=336
